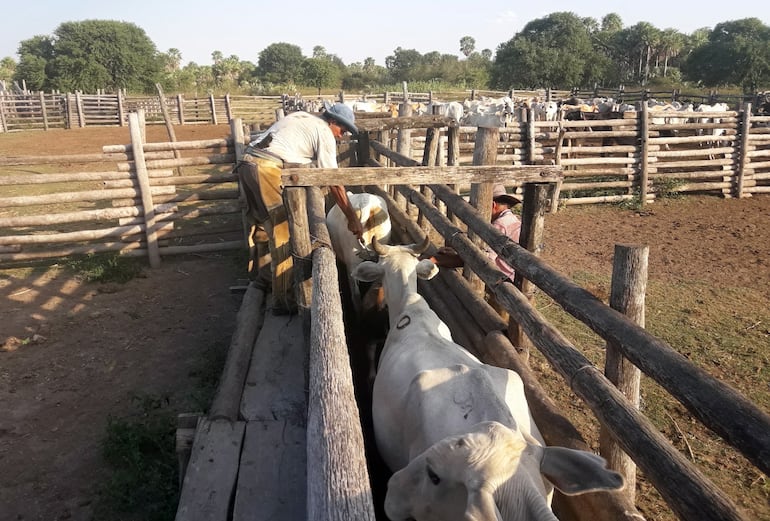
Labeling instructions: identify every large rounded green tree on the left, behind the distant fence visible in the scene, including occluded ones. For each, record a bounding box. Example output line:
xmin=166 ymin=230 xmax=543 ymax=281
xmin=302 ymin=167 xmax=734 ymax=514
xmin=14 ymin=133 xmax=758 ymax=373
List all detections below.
xmin=46 ymin=20 xmax=162 ymax=92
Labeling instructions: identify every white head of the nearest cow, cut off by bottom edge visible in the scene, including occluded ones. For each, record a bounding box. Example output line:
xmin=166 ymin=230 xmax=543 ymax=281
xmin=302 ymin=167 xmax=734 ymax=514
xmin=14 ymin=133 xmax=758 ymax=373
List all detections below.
xmin=385 ymin=422 xmax=624 ymax=521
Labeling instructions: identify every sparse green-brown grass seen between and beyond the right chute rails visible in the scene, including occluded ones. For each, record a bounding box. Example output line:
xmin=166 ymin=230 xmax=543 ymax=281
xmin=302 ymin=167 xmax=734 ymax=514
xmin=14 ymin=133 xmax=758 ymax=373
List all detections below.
xmin=531 ymin=272 xmax=770 ymax=521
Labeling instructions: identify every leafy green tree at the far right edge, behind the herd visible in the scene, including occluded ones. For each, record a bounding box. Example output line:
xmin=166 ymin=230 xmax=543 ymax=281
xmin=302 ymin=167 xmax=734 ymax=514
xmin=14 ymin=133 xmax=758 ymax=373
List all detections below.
xmin=682 ymin=18 xmax=770 ymax=91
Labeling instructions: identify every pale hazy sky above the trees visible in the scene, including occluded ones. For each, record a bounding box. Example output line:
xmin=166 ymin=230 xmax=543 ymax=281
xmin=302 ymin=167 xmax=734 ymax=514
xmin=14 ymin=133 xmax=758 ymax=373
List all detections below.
xmin=0 ymin=0 xmax=770 ymax=65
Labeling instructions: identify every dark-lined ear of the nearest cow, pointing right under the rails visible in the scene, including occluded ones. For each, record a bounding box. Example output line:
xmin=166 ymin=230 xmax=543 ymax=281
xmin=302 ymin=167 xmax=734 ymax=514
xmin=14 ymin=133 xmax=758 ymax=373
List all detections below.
xmin=540 ymin=447 xmax=625 ymax=496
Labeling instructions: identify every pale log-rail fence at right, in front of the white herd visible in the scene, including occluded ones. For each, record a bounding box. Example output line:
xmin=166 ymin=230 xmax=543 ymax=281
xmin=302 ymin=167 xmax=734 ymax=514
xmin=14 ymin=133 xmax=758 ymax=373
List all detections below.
xmin=404 ymin=104 xmax=770 ymax=203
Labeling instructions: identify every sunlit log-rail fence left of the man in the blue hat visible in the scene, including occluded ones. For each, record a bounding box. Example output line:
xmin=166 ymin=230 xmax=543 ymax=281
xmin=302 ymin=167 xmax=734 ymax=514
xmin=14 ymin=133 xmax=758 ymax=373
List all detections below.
xmin=0 ymin=113 xmax=245 ymax=265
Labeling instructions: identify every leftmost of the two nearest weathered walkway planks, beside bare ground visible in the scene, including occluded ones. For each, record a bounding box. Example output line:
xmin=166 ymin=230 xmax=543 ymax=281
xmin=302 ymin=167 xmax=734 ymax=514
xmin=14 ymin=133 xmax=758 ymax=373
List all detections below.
xmin=174 ymin=419 xmax=246 ymax=521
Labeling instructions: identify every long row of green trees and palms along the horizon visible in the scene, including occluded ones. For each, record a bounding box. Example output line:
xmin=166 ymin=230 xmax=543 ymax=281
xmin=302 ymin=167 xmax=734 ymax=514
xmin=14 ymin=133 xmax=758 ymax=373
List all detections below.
xmin=0 ymin=12 xmax=770 ymax=95
